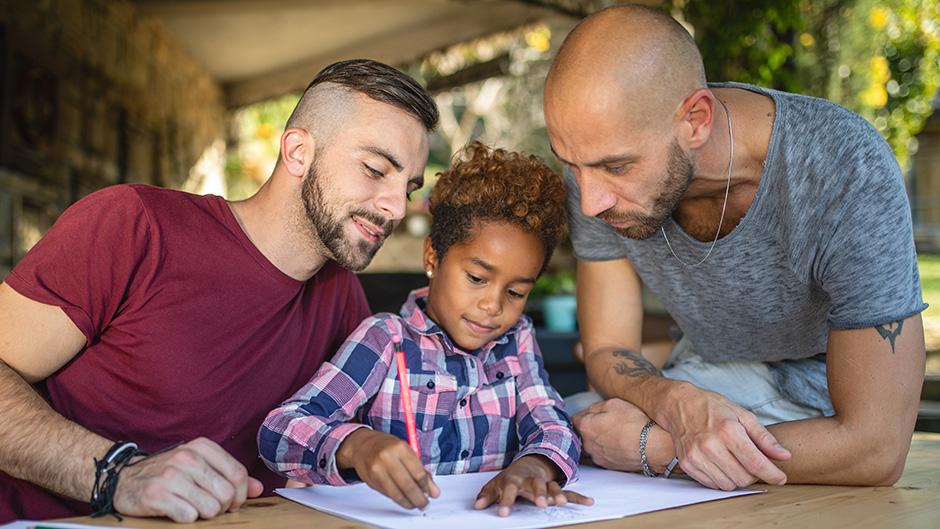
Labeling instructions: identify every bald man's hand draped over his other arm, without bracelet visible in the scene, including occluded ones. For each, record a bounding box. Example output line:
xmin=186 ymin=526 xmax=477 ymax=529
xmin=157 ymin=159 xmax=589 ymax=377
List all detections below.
xmin=663 ymin=384 xmax=790 ymax=490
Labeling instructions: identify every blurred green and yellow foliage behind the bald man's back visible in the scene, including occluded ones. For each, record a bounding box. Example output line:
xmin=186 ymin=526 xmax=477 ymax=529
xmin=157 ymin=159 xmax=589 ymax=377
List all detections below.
xmin=669 ymin=0 xmax=940 ymax=168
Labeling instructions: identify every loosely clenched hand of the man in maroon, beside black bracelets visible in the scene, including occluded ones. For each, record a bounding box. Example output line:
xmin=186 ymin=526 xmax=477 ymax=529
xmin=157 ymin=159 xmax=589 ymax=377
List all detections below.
xmin=114 ymin=438 xmax=262 ymax=522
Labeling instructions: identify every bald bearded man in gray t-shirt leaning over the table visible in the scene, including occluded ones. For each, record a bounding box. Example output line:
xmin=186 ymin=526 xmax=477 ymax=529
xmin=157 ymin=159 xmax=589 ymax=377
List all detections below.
xmin=545 ymin=6 xmax=925 ymax=490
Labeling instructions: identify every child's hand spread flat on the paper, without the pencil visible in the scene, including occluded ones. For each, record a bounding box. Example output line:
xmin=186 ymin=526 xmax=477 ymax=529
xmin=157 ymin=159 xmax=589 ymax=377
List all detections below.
xmin=473 ymin=455 xmax=594 ymax=516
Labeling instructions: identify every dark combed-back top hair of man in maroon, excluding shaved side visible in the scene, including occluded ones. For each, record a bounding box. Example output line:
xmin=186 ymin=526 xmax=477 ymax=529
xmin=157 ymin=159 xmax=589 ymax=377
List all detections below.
xmin=304 ymin=59 xmax=439 ymax=132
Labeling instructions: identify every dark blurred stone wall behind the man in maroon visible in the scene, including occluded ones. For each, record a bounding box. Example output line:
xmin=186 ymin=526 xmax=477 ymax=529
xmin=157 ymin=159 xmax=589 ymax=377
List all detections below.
xmin=0 ymin=0 xmax=225 ymax=278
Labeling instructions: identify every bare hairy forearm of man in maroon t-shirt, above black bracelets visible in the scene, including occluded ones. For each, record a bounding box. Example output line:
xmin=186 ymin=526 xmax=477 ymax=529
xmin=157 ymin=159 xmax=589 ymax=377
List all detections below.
xmin=0 ymin=362 xmax=112 ymax=501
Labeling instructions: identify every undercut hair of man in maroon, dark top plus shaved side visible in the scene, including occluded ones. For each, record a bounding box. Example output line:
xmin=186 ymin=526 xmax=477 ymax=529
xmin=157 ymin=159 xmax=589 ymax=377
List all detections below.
xmin=287 ymin=59 xmax=439 ymax=132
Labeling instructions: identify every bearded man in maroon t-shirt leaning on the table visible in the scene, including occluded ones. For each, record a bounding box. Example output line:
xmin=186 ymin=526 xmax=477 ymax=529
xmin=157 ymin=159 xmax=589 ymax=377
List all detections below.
xmin=0 ymin=60 xmax=437 ymax=522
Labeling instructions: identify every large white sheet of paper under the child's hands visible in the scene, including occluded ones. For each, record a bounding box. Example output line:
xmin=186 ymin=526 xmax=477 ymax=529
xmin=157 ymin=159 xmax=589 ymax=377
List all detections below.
xmin=277 ymin=467 xmax=763 ymax=529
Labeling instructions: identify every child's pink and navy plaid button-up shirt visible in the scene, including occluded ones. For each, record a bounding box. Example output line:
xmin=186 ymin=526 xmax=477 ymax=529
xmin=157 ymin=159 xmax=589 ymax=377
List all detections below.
xmin=258 ymin=287 xmax=581 ymax=485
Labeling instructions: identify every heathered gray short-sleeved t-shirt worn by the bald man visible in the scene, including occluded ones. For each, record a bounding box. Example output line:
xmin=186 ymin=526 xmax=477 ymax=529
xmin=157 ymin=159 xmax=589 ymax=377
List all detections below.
xmin=566 ymin=83 xmax=926 ymax=415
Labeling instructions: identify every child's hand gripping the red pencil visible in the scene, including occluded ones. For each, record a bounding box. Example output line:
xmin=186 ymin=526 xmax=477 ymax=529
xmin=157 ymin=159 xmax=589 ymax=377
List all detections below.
xmin=336 ymin=428 xmax=441 ymax=510
